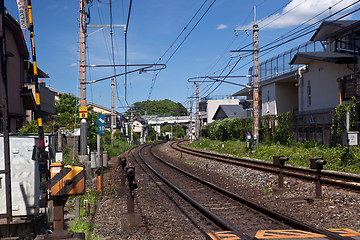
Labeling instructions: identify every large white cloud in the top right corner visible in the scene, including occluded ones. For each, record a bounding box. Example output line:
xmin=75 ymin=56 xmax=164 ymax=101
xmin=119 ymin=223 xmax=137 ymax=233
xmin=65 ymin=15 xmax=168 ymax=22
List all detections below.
xmin=237 ymin=0 xmax=359 ymax=29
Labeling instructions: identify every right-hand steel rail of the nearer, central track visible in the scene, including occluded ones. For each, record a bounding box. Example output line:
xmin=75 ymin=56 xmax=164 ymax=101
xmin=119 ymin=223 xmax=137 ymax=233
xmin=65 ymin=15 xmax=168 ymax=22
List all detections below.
xmin=150 ymin=142 xmax=347 ymax=239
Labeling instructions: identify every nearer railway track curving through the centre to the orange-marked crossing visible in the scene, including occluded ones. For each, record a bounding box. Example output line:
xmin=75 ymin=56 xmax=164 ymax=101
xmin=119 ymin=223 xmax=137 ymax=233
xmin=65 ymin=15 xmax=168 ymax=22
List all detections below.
xmin=130 ymin=143 xmax=345 ymax=239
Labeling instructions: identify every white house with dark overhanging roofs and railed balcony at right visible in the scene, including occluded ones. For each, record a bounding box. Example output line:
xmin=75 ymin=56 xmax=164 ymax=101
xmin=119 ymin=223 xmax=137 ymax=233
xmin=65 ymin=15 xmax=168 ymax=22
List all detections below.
xmin=234 ymin=20 xmax=360 ymax=144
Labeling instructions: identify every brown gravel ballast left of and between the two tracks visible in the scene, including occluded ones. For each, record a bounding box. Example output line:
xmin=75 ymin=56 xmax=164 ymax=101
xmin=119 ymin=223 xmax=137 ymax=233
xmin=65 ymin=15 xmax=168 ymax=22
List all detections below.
xmin=89 ymin=144 xmax=360 ymax=239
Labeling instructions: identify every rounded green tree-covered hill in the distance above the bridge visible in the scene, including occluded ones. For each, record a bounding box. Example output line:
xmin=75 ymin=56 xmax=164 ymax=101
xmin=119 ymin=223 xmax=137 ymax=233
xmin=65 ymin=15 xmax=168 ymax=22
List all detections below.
xmin=127 ymin=99 xmax=187 ymax=116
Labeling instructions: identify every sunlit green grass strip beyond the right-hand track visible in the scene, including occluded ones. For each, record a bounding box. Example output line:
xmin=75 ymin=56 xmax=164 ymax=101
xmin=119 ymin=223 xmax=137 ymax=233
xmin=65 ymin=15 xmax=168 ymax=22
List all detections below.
xmin=189 ymin=138 xmax=360 ymax=174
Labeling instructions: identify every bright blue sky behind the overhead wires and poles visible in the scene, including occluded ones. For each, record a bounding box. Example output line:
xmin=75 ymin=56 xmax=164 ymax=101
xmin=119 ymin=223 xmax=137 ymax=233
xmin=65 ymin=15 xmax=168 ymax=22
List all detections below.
xmin=5 ymin=0 xmax=360 ymax=112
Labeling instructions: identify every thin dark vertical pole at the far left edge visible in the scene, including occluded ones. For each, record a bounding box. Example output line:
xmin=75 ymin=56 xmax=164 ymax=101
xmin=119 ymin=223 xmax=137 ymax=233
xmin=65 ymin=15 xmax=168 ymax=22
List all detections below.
xmin=0 ymin=0 xmax=12 ymax=225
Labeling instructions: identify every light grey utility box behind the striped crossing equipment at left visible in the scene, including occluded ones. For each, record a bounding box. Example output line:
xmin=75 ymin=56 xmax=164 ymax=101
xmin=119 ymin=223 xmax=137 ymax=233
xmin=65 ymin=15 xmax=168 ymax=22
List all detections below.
xmin=0 ymin=135 xmax=55 ymax=217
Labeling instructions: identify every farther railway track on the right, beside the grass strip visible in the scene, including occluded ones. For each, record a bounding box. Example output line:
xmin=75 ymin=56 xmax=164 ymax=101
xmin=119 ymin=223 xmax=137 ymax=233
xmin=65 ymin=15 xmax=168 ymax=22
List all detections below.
xmin=171 ymin=142 xmax=360 ymax=192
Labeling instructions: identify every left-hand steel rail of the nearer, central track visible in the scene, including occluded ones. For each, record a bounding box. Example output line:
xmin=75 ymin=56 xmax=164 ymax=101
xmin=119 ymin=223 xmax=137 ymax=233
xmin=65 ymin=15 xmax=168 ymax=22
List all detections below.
xmin=134 ymin=142 xmax=251 ymax=240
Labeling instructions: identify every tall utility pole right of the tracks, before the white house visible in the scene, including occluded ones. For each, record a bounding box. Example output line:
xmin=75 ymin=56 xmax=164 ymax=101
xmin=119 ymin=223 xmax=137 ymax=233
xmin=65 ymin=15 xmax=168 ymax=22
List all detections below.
xmin=253 ymin=7 xmax=259 ymax=151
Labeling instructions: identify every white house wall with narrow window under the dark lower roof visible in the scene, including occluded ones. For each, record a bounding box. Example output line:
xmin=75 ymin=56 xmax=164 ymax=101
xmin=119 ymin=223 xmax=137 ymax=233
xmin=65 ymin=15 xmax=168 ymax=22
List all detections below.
xmin=299 ymin=60 xmax=353 ymax=112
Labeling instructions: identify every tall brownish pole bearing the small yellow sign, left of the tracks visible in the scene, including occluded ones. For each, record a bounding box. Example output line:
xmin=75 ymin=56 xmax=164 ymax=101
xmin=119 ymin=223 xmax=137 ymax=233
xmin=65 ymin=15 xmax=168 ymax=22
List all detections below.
xmin=80 ymin=0 xmax=87 ymax=155
